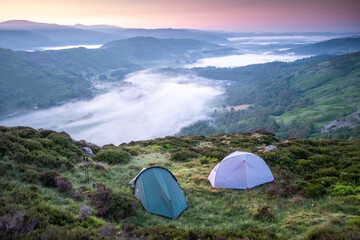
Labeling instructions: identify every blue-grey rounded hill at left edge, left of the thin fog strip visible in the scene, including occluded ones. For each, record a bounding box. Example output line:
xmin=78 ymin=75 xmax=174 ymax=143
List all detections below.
xmin=0 ymin=30 xmax=59 ymax=50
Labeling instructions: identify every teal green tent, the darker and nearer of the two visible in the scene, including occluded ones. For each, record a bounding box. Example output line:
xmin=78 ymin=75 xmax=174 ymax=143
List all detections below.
xmin=129 ymin=167 xmax=187 ymax=219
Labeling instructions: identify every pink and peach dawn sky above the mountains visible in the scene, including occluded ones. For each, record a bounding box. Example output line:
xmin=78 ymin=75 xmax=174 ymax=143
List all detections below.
xmin=0 ymin=0 xmax=360 ymax=32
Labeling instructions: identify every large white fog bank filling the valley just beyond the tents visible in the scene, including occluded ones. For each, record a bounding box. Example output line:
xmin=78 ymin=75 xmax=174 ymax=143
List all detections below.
xmin=0 ymin=70 xmax=223 ymax=145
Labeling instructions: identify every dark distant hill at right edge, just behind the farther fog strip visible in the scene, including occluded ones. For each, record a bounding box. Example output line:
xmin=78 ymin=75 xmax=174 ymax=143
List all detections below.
xmin=282 ymin=37 xmax=360 ymax=55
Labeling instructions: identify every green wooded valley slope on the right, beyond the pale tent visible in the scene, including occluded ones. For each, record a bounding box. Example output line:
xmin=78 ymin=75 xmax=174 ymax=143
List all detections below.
xmin=186 ymin=53 xmax=360 ymax=138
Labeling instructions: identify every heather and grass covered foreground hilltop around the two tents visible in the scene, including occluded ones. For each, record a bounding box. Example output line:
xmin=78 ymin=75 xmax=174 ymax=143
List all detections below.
xmin=0 ymin=127 xmax=360 ymax=239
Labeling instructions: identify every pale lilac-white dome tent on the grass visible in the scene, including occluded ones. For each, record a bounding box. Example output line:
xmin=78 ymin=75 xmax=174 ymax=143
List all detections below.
xmin=208 ymin=152 xmax=275 ymax=189
